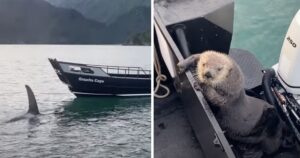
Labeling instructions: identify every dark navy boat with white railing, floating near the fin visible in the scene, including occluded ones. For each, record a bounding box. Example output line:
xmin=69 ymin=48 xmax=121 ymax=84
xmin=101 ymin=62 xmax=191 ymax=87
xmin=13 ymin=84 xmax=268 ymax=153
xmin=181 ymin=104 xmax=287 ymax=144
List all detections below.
xmin=49 ymin=59 xmax=151 ymax=96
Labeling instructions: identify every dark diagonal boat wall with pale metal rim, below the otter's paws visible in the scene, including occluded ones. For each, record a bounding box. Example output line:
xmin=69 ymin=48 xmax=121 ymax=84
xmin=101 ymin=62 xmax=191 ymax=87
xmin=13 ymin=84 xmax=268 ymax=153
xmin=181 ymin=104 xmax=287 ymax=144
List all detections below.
xmin=176 ymin=72 xmax=235 ymax=158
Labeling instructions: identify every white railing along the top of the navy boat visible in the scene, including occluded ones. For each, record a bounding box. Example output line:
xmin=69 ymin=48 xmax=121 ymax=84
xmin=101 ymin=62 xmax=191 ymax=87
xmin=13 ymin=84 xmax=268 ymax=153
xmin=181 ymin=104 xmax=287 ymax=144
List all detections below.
xmin=89 ymin=65 xmax=151 ymax=75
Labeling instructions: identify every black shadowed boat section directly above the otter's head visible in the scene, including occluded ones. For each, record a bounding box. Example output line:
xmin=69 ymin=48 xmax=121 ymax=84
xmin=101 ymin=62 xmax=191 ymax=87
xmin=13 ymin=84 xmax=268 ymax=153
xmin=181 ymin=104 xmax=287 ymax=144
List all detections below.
xmin=167 ymin=18 xmax=231 ymax=54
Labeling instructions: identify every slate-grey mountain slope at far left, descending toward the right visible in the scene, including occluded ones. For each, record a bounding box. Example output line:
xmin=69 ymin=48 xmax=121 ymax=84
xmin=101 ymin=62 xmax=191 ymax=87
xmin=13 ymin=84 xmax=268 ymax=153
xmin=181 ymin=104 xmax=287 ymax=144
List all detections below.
xmin=0 ymin=0 xmax=111 ymax=44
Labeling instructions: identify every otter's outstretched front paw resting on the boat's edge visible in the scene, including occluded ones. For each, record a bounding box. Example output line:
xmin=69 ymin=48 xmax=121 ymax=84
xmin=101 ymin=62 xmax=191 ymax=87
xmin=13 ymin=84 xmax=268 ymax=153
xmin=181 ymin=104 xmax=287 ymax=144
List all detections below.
xmin=177 ymin=54 xmax=200 ymax=74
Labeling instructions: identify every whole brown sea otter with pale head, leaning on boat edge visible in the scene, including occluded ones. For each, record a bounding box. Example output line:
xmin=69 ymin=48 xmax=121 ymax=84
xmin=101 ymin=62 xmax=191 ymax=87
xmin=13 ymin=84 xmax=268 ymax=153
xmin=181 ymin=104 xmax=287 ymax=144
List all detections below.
xmin=178 ymin=51 xmax=282 ymax=157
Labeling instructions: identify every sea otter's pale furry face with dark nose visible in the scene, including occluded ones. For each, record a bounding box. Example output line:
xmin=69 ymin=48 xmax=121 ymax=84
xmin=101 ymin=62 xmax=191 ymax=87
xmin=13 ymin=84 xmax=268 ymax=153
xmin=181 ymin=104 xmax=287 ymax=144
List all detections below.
xmin=197 ymin=52 xmax=231 ymax=86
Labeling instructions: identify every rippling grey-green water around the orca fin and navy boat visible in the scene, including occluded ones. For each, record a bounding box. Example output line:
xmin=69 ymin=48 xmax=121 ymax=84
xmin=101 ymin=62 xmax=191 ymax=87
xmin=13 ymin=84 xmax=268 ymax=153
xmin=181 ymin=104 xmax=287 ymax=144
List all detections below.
xmin=0 ymin=45 xmax=151 ymax=158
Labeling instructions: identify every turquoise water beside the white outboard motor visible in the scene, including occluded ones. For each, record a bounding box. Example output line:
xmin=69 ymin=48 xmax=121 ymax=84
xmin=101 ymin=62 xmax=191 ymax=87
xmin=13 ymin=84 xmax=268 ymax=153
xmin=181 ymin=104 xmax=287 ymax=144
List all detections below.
xmin=231 ymin=0 xmax=300 ymax=67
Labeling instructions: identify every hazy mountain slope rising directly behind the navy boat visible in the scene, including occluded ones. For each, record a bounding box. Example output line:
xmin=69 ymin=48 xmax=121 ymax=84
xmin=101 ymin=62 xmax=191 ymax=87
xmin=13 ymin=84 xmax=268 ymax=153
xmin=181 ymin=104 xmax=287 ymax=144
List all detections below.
xmin=46 ymin=0 xmax=151 ymax=43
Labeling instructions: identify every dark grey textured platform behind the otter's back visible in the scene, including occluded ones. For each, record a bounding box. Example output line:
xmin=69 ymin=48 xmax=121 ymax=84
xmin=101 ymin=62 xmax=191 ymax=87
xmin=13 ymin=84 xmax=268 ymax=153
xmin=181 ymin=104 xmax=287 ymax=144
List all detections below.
xmin=229 ymin=48 xmax=263 ymax=89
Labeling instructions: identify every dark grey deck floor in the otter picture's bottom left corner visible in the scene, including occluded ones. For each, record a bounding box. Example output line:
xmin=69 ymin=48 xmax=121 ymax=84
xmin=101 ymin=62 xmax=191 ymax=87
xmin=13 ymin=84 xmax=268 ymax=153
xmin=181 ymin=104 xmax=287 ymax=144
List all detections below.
xmin=154 ymin=93 xmax=204 ymax=158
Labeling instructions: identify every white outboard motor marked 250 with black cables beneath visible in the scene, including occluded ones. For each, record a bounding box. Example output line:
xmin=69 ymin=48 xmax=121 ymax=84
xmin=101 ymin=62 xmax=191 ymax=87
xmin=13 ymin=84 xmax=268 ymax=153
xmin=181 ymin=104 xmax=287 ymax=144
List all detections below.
xmin=262 ymin=10 xmax=300 ymax=142
